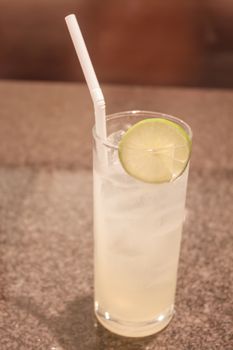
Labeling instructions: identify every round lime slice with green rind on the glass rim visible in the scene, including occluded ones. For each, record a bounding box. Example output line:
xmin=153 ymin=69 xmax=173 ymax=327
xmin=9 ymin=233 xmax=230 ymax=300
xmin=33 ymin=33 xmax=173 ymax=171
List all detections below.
xmin=118 ymin=118 xmax=191 ymax=183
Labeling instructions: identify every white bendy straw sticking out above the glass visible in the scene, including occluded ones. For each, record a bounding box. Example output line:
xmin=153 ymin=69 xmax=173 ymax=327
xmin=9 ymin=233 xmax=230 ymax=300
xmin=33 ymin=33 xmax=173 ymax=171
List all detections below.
xmin=65 ymin=14 xmax=106 ymax=140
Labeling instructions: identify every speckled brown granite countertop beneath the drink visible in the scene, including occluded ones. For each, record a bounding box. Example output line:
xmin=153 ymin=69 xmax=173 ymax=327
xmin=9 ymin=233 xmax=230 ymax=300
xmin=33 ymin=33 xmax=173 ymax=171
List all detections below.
xmin=0 ymin=81 xmax=233 ymax=350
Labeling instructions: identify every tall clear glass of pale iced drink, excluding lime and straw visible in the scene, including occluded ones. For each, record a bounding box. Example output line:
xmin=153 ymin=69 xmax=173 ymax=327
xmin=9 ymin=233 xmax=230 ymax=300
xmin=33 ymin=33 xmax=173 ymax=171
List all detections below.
xmin=93 ymin=111 xmax=192 ymax=337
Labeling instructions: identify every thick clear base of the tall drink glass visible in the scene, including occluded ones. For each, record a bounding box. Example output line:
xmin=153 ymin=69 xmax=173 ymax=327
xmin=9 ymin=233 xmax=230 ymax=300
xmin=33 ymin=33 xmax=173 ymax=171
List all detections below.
xmin=95 ymin=306 xmax=174 ymax=338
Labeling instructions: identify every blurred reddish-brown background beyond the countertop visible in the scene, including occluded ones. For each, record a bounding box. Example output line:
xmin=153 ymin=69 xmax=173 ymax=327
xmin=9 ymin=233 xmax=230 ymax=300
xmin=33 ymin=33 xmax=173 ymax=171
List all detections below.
xmin=0 ymin=0 xmax=233 ymax=88
